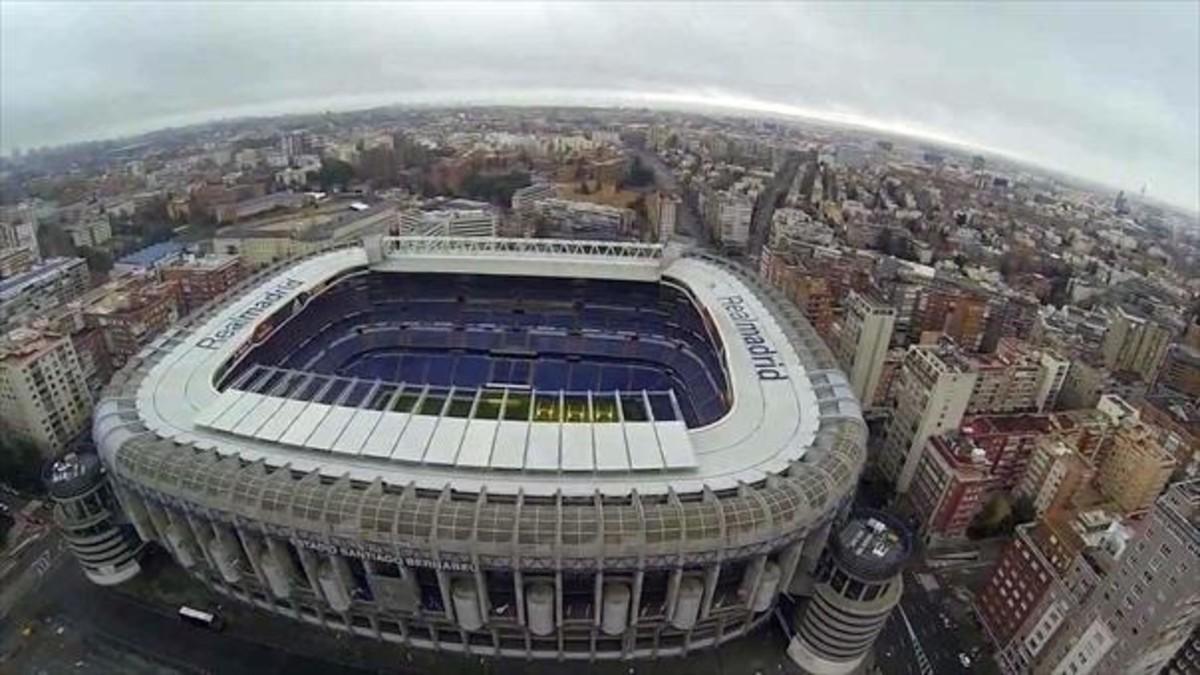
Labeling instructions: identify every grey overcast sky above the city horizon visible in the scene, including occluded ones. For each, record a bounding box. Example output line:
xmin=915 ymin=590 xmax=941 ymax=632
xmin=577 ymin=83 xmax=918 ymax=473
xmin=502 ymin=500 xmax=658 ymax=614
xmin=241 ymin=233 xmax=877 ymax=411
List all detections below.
xmin=0 ymin=0 xmax=1200 ymax=210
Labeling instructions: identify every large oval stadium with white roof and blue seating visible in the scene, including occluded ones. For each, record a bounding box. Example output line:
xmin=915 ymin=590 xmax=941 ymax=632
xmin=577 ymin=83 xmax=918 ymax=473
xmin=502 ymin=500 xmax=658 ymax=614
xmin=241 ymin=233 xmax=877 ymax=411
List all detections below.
xmin=89 ymin=237 xmax=866 ymax=658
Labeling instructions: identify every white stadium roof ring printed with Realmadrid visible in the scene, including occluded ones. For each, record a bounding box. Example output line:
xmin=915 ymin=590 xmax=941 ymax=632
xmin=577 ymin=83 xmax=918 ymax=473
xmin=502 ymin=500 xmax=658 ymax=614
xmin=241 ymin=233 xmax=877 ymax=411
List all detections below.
xmin=126 ymin=238 xmax=859 ymax=495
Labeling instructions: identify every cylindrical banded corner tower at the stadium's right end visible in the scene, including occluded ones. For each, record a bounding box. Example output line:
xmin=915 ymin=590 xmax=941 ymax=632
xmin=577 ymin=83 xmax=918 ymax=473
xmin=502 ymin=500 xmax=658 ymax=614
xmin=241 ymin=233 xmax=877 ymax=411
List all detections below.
xmin=787 ymin=510 xmax=912 ymax=675
